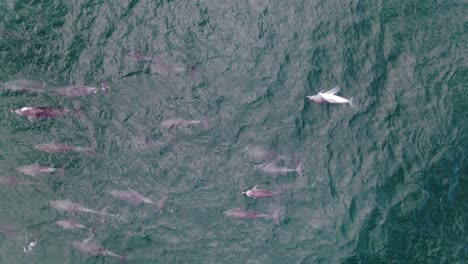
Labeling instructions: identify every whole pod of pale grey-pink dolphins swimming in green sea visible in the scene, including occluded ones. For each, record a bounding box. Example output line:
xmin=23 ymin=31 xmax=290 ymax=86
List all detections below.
xmin=0 ymin=51 xmax=354 ymax=263
